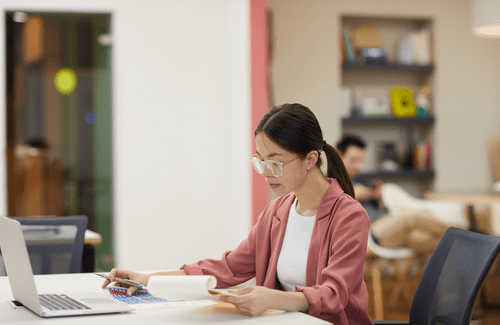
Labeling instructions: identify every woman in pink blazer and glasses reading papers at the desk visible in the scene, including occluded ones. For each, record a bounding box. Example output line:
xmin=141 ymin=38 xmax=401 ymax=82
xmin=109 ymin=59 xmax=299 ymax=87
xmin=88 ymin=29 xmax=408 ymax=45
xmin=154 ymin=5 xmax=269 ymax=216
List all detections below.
xmin=103 ymin=104 xmax=372 ymax=325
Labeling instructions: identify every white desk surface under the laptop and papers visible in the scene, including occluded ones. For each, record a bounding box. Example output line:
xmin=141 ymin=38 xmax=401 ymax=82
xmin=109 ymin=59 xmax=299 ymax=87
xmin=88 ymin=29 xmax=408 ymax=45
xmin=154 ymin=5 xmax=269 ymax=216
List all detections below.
xmin=0 ymin=273 xmax=330 ymax=325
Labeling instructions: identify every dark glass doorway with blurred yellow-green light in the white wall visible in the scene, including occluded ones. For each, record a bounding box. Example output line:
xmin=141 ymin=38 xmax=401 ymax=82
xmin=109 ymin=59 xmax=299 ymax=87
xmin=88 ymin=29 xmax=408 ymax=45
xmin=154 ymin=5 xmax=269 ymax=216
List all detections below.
xmin=5 ymin=11 xmax=114 ymax=270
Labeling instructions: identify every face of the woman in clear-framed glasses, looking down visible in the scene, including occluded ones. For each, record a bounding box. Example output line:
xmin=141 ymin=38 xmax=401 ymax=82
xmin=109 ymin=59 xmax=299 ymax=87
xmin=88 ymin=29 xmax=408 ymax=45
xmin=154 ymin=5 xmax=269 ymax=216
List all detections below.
xmin=255 ymin=132 xmax=314 ymax=196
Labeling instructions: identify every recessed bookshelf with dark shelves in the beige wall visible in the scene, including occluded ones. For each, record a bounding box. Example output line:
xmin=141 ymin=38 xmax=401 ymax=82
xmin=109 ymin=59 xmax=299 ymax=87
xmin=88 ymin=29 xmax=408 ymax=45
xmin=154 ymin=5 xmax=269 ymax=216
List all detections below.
xmin=340 ymin=15 xmax=436 ymax=195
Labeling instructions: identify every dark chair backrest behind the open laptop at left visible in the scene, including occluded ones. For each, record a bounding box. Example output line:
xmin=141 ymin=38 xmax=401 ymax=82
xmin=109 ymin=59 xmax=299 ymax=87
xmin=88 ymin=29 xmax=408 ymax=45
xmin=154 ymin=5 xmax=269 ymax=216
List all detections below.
xmin=9 ymin=216 xmax=88 ymax=274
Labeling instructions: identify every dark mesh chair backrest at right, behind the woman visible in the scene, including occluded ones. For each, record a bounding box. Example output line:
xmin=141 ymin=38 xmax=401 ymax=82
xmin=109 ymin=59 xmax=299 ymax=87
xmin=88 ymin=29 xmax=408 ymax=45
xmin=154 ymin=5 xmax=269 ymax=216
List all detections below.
xmin=410 ymin=227 xmax=500 ymax=325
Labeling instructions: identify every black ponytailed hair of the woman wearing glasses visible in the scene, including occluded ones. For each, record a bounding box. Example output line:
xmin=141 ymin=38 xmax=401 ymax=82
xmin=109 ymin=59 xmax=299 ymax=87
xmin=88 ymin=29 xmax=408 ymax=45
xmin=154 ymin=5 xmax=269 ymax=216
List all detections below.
xmin=255 ymin=104 xmax=354 ymax=198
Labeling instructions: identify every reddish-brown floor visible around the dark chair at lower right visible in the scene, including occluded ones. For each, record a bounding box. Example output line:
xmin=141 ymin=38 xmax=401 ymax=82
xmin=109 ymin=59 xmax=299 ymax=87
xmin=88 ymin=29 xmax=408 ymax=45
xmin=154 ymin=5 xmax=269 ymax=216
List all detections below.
xmin=366 ymin=273 xmax=500 ymax=325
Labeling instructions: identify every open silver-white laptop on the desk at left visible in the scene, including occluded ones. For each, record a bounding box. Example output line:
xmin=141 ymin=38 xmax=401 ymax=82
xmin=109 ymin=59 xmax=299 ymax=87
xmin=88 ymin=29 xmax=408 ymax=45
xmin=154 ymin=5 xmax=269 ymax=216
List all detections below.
xmin=0 ymin=217 xmax=134 ymax=317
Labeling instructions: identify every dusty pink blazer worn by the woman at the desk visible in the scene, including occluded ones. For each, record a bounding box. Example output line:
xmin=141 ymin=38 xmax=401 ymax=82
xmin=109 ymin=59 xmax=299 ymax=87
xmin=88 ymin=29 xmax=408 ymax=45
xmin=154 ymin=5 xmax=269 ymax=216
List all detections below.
xmin=182 ymin=179 xmax=372 ymax=325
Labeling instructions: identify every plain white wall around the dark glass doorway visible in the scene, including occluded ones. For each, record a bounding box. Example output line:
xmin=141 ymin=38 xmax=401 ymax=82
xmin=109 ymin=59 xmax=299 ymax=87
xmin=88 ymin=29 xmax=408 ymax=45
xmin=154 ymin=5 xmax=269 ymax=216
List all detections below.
xmin=0 ymin=0 xmax=251 ymax=270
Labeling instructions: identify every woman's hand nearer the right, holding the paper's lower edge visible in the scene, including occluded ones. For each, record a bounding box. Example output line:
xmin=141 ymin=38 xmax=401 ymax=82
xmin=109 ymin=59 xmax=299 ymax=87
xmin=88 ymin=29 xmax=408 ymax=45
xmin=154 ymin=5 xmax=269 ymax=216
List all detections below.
xmin=220 ymin=286 xmax=276 ymax=316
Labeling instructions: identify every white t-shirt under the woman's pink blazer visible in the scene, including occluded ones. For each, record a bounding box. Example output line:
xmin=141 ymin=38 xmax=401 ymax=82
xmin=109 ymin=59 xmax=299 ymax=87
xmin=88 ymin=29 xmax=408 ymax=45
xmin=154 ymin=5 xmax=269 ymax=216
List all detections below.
xmin=277 ymin=198 xmax=316 ymax=291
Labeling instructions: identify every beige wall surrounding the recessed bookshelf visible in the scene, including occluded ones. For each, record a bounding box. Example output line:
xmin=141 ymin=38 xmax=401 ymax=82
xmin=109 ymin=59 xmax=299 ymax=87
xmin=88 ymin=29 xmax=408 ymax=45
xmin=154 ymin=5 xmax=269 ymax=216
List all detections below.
xmin=268 ymin=0 xmax=500 ymax=192
